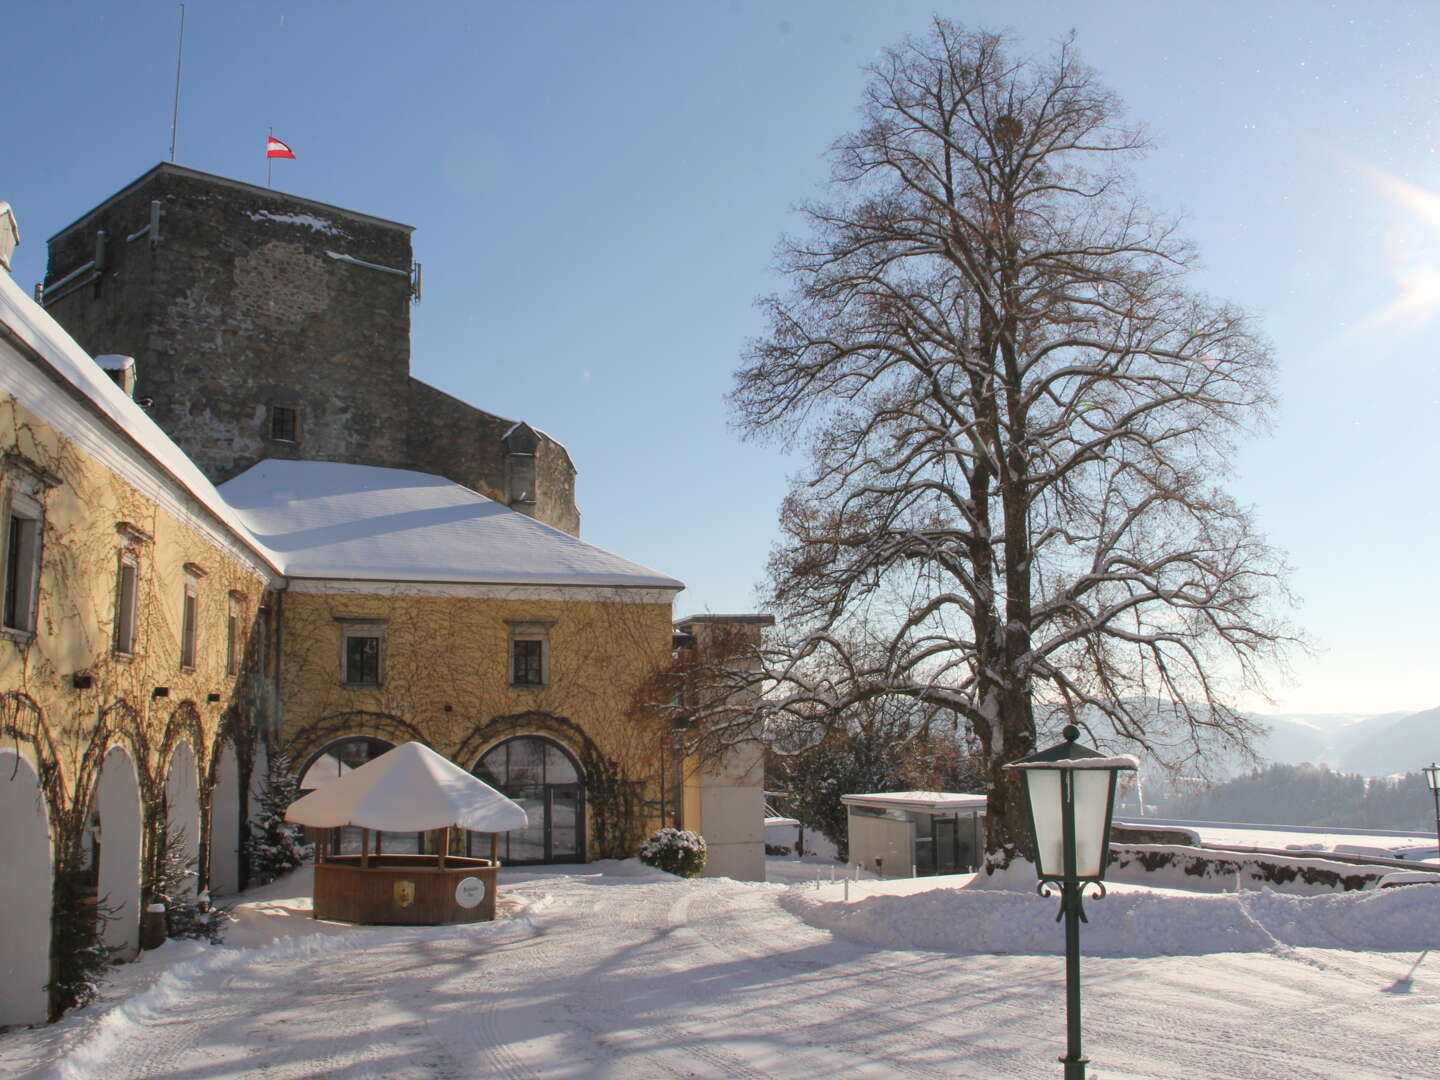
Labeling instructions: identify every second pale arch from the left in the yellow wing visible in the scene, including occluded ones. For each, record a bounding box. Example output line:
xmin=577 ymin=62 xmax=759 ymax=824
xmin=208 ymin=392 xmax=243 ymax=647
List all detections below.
xmin=91 ymin=746 xmax=141 ymax=959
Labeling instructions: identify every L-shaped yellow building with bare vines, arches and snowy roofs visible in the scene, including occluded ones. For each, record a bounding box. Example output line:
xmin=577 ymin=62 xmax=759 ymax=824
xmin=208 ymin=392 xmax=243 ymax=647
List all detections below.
xmin=0 ymin=204 xmax=702 ymax=1027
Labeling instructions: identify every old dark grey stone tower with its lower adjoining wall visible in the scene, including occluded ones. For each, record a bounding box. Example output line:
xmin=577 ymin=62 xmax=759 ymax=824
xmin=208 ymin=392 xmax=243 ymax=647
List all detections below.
xmin=42 ymin=164 xmax=580 ymax=534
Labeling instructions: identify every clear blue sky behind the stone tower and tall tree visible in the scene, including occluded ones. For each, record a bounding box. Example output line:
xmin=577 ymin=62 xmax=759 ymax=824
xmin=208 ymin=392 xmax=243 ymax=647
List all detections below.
xmin=0 ymin=8 xmax=1440 ymax=722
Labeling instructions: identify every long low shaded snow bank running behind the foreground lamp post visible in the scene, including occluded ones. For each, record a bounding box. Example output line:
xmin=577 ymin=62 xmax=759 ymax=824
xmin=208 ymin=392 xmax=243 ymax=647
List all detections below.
xmin=780 ymin=886 xmax=1440 ymax=956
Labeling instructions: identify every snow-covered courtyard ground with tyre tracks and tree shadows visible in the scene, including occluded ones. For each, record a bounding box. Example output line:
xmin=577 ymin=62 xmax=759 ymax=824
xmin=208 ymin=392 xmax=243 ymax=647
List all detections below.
xmin=0 ymin=860 xmax=1440 ymax=1080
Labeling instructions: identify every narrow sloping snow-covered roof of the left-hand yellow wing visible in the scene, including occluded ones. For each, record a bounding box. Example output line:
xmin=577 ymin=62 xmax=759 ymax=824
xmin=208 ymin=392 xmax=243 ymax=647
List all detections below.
xmin=0 ymin=274 xmax=278 ymax=569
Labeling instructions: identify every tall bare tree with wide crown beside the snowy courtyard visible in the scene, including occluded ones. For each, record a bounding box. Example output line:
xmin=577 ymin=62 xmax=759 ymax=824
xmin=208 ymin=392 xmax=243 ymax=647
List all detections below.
xmin=733 ymin=19 xmax=1293 ymax=867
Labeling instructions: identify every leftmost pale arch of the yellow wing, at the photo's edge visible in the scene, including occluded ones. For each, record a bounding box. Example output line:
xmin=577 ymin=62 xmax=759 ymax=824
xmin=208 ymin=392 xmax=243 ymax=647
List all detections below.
xmin=0 ymin=749 xmax=50 ymax=1027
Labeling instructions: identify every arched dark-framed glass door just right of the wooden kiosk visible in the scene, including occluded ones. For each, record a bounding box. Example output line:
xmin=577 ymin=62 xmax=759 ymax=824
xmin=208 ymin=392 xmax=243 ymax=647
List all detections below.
xmin=474 ymin=734 xmax=585 ymax=863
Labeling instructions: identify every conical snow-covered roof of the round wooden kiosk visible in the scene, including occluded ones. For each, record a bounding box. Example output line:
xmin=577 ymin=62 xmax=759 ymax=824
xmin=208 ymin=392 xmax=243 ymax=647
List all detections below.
xmin=285 ymin=743 xmax=528 ymax=832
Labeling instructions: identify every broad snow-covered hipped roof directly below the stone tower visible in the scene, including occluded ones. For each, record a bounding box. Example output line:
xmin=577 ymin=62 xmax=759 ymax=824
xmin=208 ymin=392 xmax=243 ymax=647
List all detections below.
xmin=220 ymin=459 xmax=685 ymax=590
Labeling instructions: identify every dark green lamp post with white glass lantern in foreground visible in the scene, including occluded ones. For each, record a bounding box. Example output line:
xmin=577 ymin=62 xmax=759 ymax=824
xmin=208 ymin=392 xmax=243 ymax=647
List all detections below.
xmin=1005 ymin=724 xmax=1139 ymax=1080
